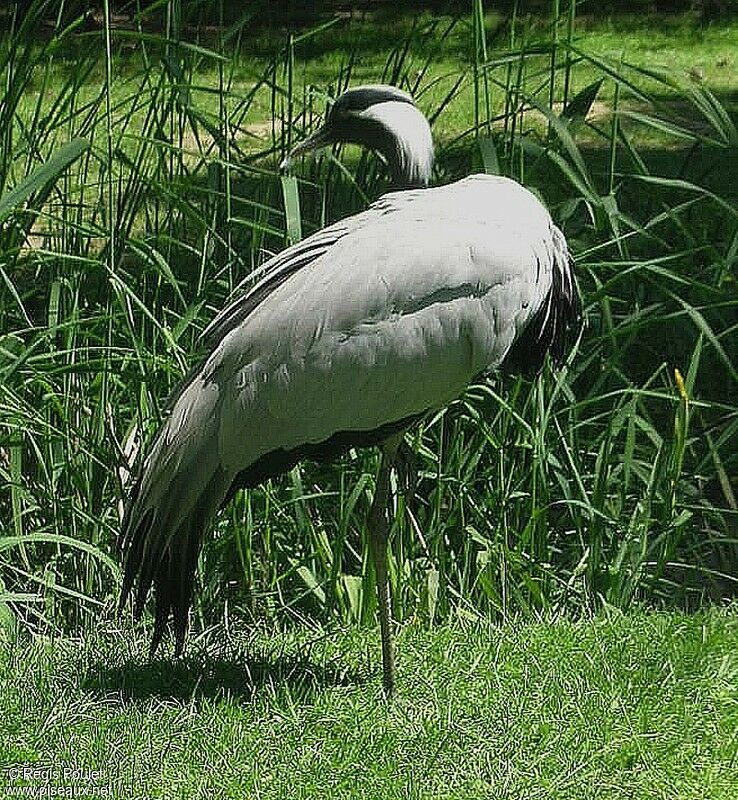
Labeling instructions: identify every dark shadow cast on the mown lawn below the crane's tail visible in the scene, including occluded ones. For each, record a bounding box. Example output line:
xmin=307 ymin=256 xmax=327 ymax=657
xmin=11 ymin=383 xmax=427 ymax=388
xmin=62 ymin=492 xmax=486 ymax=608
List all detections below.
xmin=81 ymin=654 xmax=370 ymax=704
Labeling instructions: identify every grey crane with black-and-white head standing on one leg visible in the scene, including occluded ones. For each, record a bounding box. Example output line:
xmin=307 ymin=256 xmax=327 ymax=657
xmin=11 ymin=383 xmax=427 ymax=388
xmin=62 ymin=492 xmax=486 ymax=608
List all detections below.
xmin=120 ymin=86 xmax=580 ymax=695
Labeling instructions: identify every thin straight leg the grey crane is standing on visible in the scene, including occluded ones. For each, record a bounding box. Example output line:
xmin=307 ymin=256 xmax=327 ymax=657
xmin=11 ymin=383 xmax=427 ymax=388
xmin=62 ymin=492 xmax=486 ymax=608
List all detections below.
xmin=368 ymin=433 xmax=402 ymax=698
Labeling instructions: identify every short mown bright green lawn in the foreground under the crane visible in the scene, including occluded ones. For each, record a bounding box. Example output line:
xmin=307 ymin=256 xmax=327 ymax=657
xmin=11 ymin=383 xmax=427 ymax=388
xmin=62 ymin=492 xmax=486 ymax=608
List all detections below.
xmin=0 ymin=607 xmax=738 ymax=800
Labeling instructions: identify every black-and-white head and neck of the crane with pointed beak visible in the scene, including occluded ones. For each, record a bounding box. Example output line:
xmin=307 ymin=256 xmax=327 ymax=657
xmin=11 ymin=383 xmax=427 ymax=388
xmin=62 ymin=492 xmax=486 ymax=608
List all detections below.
xmin=280 ymin=84 xmax=433 ymax=189
